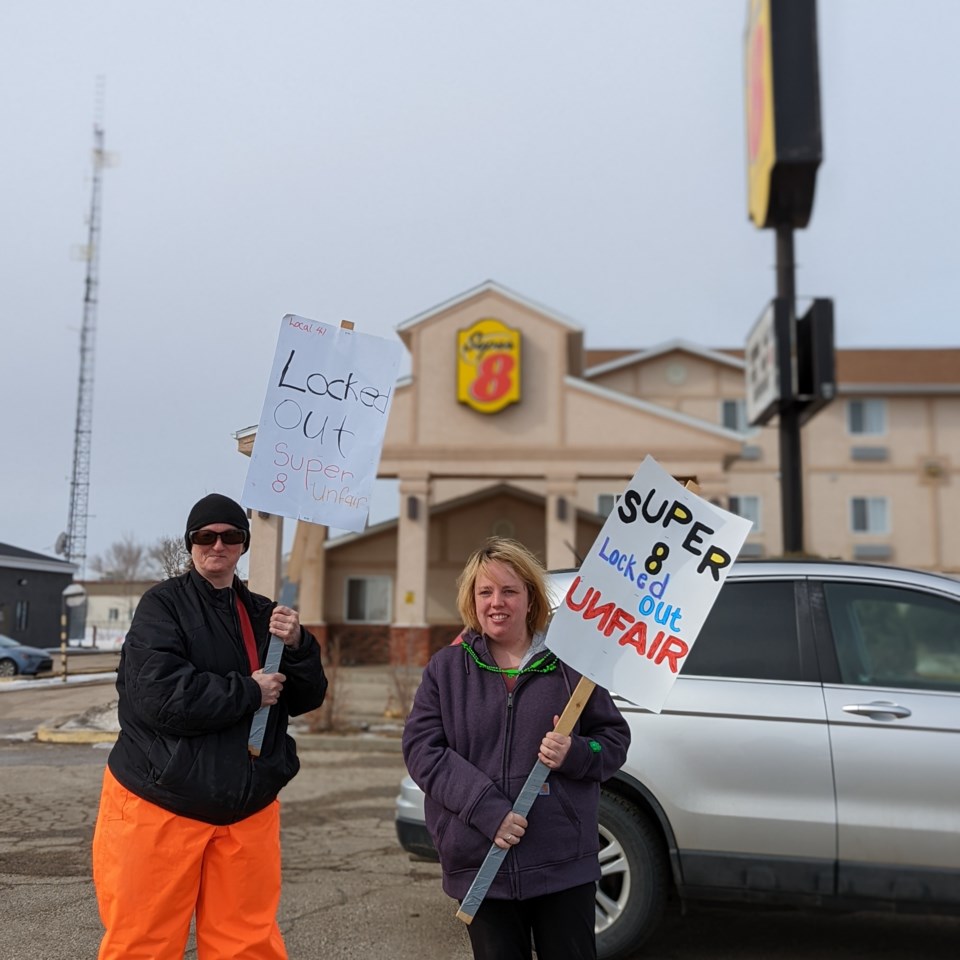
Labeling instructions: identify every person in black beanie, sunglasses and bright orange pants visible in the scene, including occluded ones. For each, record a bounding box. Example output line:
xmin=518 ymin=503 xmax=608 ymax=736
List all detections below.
xmin=93 ymin=493 xmax=327 ymax=960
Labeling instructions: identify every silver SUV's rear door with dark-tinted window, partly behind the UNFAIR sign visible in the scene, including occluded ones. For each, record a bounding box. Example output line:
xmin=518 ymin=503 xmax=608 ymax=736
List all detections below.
xmin=626 ymin=579 xmax=836 ymax=895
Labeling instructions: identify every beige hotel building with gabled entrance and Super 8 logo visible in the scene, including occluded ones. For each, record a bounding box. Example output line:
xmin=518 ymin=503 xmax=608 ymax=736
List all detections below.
xmin=236 ymin=282 xmax=960 ymax=663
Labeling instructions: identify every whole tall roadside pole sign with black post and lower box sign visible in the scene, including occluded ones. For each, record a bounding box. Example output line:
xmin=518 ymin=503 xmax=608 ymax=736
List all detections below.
xmin=744 ymin=0 xmax=833 ymax=553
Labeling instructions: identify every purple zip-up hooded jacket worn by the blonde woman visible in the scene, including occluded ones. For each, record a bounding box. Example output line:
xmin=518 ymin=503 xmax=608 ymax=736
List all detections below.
xmin=403 ymin=630 xmax=630 ymax=900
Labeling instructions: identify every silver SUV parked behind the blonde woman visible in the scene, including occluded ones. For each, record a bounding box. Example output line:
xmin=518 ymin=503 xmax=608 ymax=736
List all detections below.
xmin=397 ymin=561 xmax=960 ymax=960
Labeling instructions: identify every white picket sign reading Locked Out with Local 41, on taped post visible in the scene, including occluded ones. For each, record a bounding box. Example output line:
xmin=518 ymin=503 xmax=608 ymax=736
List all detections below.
xmin=241 ymin=313 xmax=401 ymax=756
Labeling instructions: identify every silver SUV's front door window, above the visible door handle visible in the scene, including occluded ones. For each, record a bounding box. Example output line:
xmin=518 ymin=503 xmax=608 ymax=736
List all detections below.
xmin=823 ymin=583 xmax=960 ymax=691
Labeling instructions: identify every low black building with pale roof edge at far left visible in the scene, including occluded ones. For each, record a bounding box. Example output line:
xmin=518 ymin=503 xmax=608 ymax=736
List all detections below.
xmin=0 ymin=543 xmax=76 ymax=649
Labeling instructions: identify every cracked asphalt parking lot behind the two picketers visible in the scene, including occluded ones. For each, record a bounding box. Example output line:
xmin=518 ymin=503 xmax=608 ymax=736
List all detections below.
xmin=0 ymin=664 xmax=470 ymax=960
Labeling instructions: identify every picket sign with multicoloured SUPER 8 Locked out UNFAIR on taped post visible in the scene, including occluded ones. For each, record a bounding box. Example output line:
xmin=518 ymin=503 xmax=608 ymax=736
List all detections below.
xmin=457 ymin=457 xmax=751 ymax=923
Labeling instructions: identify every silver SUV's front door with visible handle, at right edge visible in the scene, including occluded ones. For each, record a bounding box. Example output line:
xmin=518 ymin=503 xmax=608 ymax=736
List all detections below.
xmin=823 ymin=582 xmax=960 ymax=902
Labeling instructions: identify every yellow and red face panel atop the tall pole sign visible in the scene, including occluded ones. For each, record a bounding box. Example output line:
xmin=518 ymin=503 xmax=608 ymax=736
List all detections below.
xmin=745 ymin=0 xmax=777 ymax=227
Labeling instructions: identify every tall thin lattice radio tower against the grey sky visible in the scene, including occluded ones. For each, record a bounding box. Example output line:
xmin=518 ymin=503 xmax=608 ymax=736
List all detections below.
xmin=57 ymin=94 xmax=107 ymax=580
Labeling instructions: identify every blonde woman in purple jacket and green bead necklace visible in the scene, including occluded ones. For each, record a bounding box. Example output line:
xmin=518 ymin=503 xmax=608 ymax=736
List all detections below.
xmin=403 ymin=538 xmax=630 ymax=960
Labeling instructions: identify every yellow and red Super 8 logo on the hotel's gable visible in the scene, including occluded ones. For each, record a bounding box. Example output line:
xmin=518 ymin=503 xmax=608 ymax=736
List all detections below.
xmin=457 ymin=318 xmax=520 ymax=413
